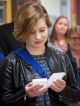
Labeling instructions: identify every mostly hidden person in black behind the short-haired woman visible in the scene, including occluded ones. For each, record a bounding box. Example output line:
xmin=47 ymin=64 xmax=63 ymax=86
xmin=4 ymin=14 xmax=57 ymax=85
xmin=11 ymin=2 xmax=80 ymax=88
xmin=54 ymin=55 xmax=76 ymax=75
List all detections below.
xmin=0 ymin=0 xmax=41 ymax=56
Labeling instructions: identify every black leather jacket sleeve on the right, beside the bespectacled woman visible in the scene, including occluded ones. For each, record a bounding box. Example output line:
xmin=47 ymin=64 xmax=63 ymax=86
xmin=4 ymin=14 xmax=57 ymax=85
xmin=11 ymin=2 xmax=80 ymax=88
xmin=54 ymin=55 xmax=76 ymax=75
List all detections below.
xmin=59 ymin=55 xmax=80 ymax=104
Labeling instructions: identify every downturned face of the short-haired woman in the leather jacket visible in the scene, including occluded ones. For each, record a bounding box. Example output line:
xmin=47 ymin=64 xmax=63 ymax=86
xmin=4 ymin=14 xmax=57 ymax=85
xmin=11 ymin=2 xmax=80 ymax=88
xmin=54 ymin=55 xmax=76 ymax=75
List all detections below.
xmin=26 ymin=18 xmax=48 ymax=49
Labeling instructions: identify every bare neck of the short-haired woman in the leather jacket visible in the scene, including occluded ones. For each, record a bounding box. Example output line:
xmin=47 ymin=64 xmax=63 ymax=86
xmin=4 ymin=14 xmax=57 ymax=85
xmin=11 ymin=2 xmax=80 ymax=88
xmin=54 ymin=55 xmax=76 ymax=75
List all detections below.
xmin=26 ymin=46 xmax=45 ymax=55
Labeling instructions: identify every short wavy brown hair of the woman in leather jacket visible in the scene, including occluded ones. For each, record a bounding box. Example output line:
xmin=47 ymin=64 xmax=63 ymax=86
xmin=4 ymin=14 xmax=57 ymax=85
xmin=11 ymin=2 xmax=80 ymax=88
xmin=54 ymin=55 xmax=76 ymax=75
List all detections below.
xmin=14 ymin=3 xmax=51 ymax=41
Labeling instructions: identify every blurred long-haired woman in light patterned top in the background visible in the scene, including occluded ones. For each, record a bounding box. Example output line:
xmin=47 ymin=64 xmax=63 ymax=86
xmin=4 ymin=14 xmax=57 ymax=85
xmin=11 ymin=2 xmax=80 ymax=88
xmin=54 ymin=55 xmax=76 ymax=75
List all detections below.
xmin=50 ymin=16 xmax=69 ymax=52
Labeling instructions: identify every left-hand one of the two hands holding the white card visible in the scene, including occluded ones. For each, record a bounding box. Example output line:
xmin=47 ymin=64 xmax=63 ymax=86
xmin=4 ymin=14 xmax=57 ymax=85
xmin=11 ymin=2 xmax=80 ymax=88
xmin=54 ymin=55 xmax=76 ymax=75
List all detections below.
xmin=25 ymin=82 xmax=48 ymax=97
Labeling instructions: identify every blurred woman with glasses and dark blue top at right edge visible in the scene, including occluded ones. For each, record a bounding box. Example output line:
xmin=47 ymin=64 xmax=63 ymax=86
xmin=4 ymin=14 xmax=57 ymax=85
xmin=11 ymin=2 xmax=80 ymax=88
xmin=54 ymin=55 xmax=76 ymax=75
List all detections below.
xmin=67 ymin=26 xmax=80 ymax=106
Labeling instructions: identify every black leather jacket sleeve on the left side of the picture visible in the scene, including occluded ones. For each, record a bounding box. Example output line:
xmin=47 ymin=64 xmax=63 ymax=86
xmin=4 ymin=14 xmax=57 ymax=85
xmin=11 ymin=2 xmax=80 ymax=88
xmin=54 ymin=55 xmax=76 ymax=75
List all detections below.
xmin=0 ymin=59 xmax=25 ymax=104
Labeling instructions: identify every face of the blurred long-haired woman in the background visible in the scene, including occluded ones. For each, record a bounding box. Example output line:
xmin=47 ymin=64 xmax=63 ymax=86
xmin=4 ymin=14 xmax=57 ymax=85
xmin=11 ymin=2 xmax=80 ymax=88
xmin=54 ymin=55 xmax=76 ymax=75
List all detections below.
xmin=55 ymin=18 xmax=68 ymax=35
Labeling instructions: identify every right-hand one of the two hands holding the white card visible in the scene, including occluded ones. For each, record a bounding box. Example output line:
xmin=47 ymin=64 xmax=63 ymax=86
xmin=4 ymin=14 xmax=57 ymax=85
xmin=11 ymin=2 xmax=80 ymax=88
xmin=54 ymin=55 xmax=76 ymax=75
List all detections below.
xmin=50 ymin=80 xmax=66 ymax=92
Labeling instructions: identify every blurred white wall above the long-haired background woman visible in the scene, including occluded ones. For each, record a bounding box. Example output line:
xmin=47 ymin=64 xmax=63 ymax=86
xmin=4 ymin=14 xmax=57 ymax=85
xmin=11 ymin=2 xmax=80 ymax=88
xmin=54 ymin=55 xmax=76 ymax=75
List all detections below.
xmin=41 ymin=0 xmax=71 ymax=25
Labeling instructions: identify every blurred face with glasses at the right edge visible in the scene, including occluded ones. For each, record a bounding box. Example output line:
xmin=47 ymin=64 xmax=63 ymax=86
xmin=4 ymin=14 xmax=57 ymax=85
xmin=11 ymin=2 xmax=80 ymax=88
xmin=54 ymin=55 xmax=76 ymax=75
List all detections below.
xmin=68 ymin=33 xmax=80 ymax=51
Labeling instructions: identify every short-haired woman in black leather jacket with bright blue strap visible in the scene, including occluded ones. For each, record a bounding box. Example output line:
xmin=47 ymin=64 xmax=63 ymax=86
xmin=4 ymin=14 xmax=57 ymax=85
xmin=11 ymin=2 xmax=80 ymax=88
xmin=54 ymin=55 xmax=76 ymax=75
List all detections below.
xmin=0 ymin=3 xmax=80 ymax=106
